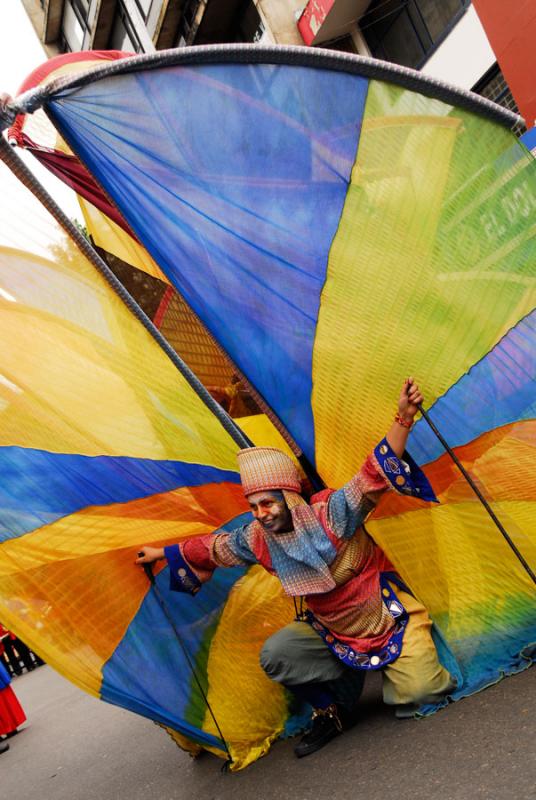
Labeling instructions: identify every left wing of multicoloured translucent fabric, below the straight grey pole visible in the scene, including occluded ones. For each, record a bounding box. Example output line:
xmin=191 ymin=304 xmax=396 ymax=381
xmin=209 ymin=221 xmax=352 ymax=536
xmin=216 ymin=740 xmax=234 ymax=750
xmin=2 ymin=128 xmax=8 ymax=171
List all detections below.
xmin=0 ymin=166 xmax=308 ymax=768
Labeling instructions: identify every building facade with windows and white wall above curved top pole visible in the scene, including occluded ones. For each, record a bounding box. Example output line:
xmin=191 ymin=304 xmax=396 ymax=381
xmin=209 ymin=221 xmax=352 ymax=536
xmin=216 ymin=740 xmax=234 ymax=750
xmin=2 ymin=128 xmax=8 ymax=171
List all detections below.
xmin=22 ymin=0 xmax=518 ymax=128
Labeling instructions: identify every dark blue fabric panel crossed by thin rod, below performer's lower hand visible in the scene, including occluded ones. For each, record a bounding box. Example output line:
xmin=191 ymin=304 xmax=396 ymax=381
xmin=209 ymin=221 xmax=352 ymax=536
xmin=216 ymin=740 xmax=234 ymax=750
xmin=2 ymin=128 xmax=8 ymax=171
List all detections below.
xmin=101 ymin=556 xmax=246 ymax=746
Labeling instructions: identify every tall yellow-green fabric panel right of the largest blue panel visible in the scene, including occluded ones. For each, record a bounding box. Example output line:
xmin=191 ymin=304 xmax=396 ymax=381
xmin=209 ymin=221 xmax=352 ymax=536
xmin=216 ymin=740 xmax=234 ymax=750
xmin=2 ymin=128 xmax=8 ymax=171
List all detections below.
xmin=312 ymin=81 xmax=536 ymax=486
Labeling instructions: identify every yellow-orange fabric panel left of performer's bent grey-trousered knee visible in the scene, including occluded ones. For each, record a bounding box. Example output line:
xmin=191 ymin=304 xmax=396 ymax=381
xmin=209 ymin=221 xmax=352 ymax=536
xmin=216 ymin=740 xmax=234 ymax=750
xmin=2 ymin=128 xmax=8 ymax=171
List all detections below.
xmin=203 ymin=567 xmax=294 ymax=770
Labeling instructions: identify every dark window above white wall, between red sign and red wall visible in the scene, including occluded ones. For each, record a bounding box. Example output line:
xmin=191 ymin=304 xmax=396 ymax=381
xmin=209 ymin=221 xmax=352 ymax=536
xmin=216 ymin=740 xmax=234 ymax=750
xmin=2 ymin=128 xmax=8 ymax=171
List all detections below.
xmin=360 ymin=0 xmax=470 ymax=67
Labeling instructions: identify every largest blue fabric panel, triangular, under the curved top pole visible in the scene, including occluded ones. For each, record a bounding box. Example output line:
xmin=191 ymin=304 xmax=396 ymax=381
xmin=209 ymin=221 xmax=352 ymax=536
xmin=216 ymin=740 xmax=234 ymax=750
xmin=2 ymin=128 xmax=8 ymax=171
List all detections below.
xmin=47 ymin=64 xmax=368 ymax=462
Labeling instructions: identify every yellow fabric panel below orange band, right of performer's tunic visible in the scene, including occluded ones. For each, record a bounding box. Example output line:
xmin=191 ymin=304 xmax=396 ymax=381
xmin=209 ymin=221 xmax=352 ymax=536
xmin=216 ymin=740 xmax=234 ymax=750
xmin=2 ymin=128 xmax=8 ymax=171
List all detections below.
xmin=367 ymin=497 xmax=536 ymax=640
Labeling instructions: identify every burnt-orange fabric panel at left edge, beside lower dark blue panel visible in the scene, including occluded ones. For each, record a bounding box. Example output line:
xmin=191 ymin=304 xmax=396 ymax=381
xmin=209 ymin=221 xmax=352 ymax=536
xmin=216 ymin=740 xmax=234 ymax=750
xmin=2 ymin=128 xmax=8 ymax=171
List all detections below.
xmin=0 ymin=548 xmax=147 ymax=696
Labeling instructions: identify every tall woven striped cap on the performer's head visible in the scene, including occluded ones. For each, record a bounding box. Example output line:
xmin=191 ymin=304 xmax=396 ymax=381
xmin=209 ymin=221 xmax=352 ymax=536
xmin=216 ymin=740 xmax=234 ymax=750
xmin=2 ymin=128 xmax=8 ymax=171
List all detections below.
xmin=238 ymin=447 xmax=301 ymax=497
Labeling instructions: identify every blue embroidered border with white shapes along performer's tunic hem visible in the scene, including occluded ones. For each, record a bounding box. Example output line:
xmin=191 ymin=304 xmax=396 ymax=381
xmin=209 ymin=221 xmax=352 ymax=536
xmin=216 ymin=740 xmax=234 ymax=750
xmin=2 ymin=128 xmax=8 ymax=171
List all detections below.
xmin=305 ymin=572 xmax=410 ymax=670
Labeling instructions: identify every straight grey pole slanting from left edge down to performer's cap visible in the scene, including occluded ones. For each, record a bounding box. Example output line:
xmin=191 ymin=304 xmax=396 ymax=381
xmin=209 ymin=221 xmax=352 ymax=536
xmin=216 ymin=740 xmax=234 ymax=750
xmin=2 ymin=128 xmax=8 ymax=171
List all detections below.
xmin=0 ymin=134 xmax=252 ymax=448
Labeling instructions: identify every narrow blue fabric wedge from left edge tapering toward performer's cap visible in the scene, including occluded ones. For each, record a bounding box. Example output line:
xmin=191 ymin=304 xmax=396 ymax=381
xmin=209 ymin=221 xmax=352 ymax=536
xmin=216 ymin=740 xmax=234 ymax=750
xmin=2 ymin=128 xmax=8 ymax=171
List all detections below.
xmin=0 ymin=447 xmax=240 ymax=542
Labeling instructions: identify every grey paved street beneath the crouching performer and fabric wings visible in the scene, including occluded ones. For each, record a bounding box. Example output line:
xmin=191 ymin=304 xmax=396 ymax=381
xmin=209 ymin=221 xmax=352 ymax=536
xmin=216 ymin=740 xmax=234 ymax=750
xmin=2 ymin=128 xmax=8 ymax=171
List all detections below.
xmin=4 ymin=667 xmax=536 ymax=800
